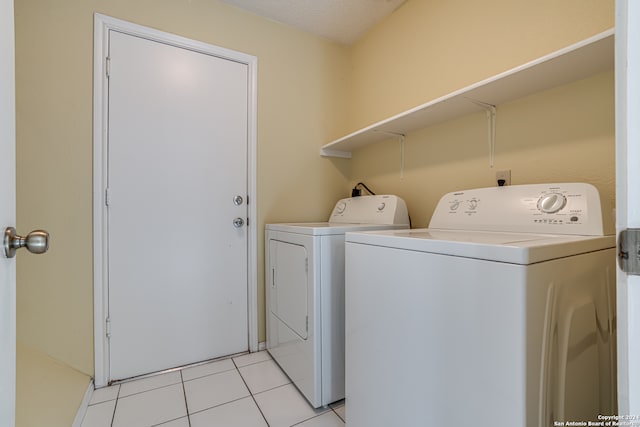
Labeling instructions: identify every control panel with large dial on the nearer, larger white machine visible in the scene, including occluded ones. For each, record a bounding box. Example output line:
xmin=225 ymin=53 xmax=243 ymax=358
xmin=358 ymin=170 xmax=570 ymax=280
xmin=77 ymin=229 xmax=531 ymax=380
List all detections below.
xmin=429 ymin=183 xmax=615 ymax=236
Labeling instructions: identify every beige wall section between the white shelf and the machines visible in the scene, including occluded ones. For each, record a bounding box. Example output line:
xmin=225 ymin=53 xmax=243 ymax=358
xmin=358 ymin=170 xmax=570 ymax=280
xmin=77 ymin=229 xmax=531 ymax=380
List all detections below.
xmin=351 ymin=72 xmax=615 ymax=227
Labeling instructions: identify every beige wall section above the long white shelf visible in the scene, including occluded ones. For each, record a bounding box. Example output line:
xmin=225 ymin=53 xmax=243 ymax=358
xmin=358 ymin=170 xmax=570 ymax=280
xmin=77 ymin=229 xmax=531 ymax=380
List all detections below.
xmin=349 ymin=0 xmax=614 ymax=130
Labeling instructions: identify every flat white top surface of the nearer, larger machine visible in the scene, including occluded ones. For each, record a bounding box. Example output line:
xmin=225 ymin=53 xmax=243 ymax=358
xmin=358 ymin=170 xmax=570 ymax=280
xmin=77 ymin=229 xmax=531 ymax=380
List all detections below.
xmin=345 ymin=229 xmax=615 ymax=265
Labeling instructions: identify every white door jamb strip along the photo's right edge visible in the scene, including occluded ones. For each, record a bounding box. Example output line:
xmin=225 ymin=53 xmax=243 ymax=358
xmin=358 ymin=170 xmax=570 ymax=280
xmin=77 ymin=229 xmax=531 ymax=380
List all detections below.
xmin=616 ymin=0 xmax=640 ymax=416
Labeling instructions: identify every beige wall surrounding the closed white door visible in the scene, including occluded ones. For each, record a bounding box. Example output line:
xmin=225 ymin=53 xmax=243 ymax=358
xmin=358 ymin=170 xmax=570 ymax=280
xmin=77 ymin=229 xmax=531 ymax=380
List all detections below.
xmin=15 ymin=0 xmax=348 ymax=374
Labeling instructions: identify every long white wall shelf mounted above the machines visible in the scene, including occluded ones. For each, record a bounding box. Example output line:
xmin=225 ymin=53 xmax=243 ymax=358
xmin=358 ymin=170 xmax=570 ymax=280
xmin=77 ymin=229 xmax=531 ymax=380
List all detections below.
xmin=320 ymin=29 xmax=614 ymax=158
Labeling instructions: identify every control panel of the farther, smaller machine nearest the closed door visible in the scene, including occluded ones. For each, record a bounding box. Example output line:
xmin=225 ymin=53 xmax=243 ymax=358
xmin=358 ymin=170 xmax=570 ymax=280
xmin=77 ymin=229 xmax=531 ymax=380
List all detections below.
xmin=329 ymin=195 xmax=409 ymax=225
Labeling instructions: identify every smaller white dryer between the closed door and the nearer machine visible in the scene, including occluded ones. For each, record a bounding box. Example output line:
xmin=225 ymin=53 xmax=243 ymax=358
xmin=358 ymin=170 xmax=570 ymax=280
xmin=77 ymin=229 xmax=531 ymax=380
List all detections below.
xmin=265 ymin=195 xmax=409 ymax=408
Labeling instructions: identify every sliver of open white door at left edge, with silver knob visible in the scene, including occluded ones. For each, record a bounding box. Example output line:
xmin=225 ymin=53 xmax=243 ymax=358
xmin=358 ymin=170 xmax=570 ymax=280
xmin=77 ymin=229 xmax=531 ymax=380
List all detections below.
xmin=0 ymin=0 xmax=16 ymax=426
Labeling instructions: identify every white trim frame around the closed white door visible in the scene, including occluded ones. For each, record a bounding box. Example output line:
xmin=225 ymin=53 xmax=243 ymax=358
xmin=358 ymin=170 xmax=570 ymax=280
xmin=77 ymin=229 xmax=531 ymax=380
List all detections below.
xmin=93 ymin=13 xmax=258 ymax=387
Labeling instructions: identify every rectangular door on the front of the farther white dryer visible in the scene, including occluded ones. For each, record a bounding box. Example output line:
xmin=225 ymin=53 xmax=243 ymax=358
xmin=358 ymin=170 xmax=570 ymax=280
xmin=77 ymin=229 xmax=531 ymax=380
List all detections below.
xmin=269 ymin=240 xmax=308 ymax=339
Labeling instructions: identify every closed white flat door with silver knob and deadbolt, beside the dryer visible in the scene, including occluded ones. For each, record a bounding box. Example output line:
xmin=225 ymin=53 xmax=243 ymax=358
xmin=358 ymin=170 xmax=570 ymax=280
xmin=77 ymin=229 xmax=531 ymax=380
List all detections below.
xmin=107 ymin=31 xmax=249 ymax=380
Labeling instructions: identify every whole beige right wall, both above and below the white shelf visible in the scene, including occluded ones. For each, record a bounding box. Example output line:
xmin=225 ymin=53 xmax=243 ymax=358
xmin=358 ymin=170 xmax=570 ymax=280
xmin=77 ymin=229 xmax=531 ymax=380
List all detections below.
xmin=336 ymin=0 xmax=615 ymax=227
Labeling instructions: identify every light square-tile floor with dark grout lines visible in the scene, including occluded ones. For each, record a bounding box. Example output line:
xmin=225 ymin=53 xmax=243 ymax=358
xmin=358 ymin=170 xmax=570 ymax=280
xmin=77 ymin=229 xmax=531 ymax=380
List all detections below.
xmin=82 ymin=351 xmax=345 ymax=427
